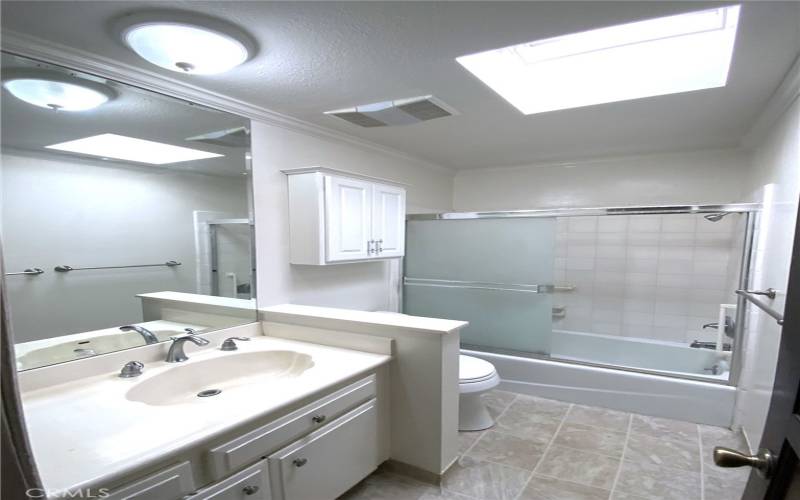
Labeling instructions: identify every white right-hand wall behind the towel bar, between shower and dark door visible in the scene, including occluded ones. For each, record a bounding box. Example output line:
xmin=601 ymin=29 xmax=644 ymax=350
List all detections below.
xmin=734 ymin=95 xmax=800 ymax=451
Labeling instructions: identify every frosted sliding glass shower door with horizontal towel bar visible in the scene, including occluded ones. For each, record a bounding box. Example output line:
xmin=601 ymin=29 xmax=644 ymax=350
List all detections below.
xmin=403 ymin=218 xmax=556 ymax=354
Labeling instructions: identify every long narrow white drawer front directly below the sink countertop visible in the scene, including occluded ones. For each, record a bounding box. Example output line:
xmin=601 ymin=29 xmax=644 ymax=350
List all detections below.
xmin=208 ymin=375 xmax=375 ymax=480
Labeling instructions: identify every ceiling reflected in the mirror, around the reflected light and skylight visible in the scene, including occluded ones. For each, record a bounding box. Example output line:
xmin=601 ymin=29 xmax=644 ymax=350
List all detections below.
xmin=0 ymin=54 xmax=250 ymax=175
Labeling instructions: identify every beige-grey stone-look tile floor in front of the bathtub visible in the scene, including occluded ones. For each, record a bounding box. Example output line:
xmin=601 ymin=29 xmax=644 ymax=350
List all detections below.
xmin=340 ymin=391 xmax=749 ymax=500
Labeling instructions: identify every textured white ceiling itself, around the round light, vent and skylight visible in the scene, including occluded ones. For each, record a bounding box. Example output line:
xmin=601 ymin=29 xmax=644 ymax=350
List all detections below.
xmin=2 ymin=1 xmax=800 ymax=169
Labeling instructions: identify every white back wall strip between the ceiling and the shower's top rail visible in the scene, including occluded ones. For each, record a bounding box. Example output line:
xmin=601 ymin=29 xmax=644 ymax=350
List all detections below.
xmin=453 ymin=150 xmax=749 ymax=210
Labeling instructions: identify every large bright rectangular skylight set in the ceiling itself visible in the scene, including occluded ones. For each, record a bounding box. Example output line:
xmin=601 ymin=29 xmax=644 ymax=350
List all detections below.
xmin=456 ymin=5 xmax=739 ymax=115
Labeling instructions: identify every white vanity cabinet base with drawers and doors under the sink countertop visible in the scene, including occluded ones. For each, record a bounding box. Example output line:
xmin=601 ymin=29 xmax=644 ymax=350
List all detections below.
xmin=100 ymin=374 xmax=389 ymax=500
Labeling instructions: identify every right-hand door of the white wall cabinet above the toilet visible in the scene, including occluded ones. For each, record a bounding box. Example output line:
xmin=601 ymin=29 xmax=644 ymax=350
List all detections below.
xmin=372 ymin=184 xmax=406 ymax=257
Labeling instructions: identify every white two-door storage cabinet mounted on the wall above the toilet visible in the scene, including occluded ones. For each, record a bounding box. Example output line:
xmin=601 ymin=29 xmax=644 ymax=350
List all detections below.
xmin=284 ymin=169 xmax=406 ymax=265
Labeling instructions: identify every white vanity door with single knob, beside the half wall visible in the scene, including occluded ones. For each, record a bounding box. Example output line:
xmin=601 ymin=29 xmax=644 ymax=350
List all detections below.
xmin=269 ymin=399 xmax=380 ymax=500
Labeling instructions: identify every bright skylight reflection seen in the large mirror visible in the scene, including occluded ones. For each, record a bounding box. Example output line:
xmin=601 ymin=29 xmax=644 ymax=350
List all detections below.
xmin=47 ymin=134 xmax=224 ymax=165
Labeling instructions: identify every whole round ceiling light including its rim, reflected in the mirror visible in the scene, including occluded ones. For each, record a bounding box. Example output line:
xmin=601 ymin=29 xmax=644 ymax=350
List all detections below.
xmin=3 ymin=69 xmax=115 ymax=111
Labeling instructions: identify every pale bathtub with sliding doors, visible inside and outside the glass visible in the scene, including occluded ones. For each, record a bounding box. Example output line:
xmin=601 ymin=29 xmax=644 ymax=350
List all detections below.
xmin=462 ymin=331 xmax=736 ymax=427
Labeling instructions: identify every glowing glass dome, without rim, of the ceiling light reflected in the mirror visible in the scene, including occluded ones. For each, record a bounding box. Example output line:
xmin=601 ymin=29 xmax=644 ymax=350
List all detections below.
xmin=3 ymin=78 xmax=109 ymax=111
